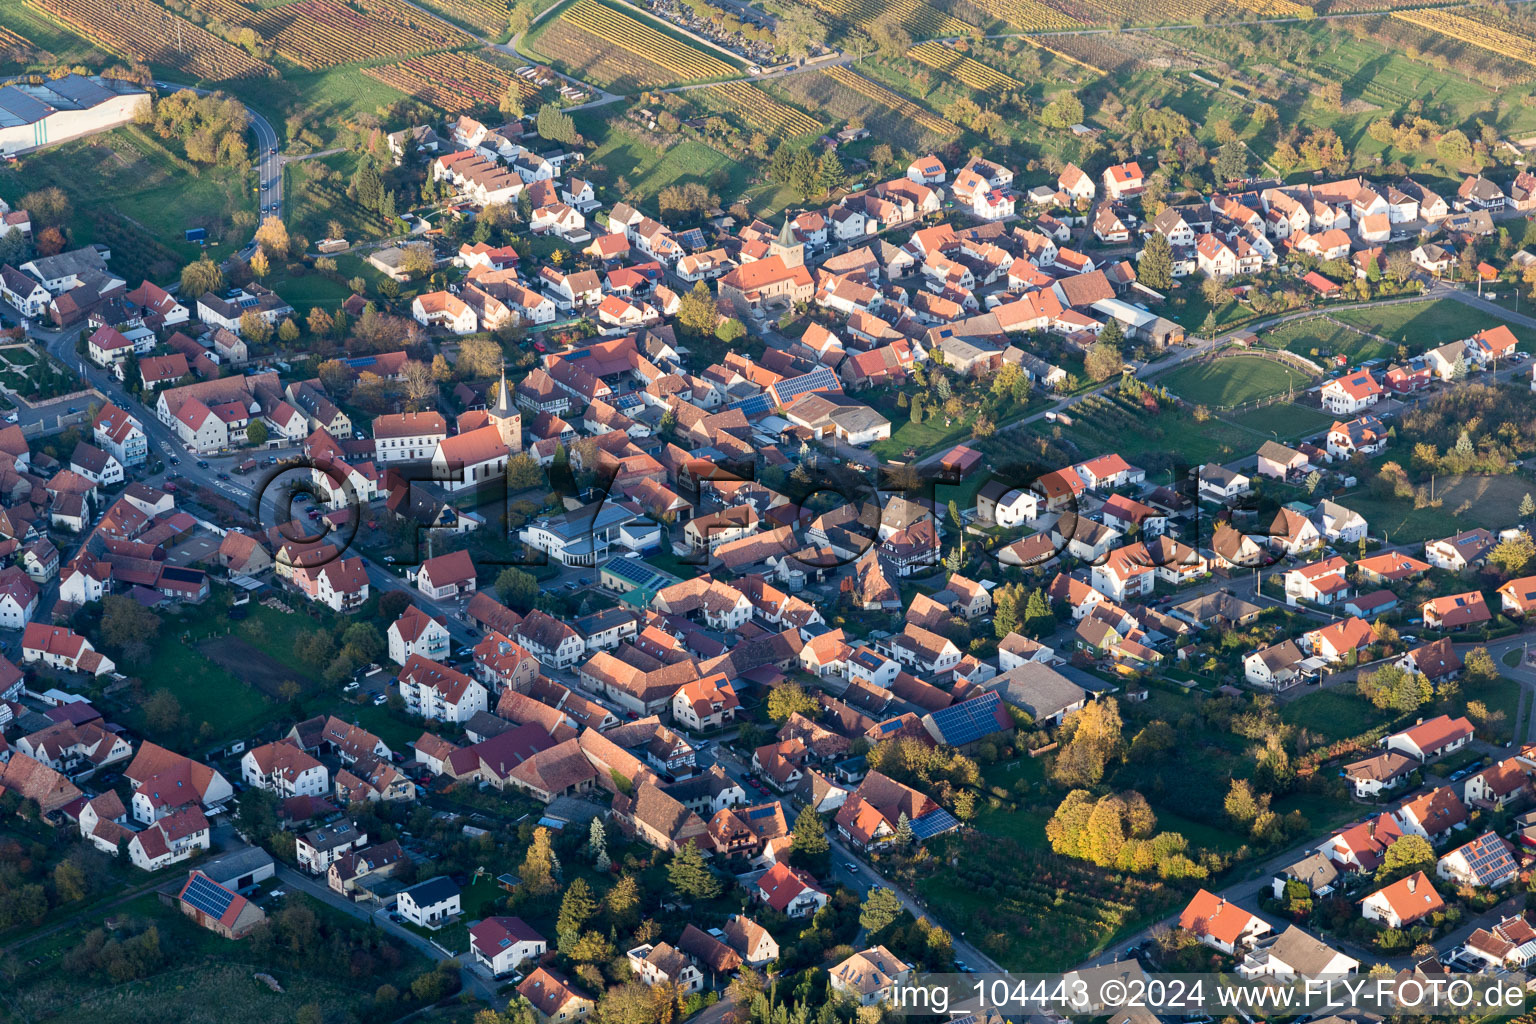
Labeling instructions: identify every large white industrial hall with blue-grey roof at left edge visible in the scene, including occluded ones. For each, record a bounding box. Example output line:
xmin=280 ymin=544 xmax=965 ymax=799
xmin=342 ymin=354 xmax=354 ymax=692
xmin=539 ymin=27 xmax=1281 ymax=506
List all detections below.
xmin=0 ymin=75 xmax=149 ymax=157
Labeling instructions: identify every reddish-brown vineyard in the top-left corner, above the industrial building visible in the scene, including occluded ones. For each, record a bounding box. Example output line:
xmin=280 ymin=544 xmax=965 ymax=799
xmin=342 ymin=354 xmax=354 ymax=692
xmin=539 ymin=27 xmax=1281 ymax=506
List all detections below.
xmin=26 ymin=0 xmax=276 ymax=81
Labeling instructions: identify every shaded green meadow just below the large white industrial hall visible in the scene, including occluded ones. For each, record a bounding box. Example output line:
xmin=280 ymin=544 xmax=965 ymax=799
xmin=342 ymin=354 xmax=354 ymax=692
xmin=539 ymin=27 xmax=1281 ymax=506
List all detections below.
xmin=0 ymin=126 xmax=257 ymax=287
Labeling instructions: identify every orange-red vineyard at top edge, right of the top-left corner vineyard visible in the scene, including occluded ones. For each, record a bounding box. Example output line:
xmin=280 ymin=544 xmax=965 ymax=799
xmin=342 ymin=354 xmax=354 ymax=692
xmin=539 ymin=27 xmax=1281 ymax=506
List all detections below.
xmin=189 ymin=0 xmax=472 ymax=71
